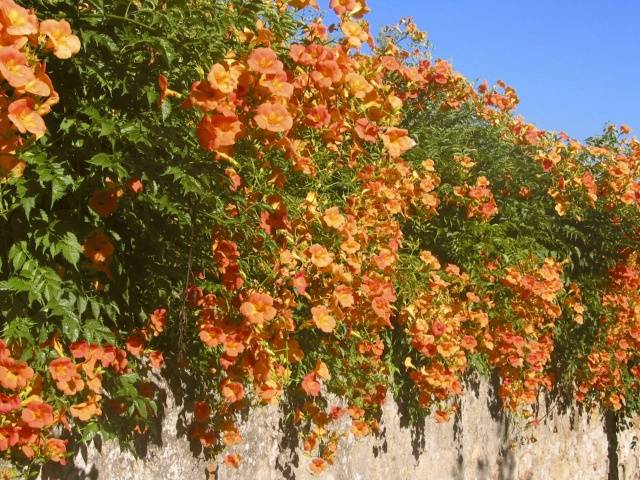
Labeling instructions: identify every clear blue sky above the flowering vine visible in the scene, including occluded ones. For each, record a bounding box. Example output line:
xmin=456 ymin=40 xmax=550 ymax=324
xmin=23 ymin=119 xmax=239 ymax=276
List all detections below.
xmin=340 ymin=0 xmax=640 ymax=139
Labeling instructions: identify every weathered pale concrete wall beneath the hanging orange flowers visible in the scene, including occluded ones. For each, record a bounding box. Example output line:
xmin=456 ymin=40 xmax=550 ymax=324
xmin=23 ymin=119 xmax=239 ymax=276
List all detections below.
xmin=48 ymin=383 xmax=640 ymax=480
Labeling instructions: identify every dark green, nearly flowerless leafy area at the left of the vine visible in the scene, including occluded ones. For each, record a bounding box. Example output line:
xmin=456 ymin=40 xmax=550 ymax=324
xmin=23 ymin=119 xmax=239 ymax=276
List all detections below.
xmin=0 ymin=0 xmax=296 ymax=458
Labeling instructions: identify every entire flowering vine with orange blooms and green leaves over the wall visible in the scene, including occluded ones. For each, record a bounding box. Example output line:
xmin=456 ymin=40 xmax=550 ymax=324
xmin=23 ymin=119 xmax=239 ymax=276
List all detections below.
xmin=0 ymin=0 xmax=640 ymax=476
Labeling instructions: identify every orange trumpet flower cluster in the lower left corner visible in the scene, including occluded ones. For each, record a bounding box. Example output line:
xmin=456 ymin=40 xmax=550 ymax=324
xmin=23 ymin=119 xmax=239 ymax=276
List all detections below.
xmin=0 ymin=339 xmax=127 ymax=464
